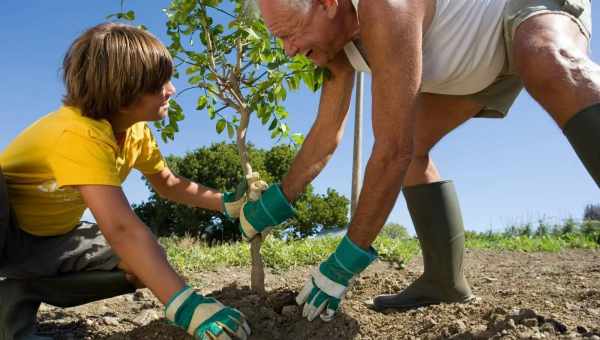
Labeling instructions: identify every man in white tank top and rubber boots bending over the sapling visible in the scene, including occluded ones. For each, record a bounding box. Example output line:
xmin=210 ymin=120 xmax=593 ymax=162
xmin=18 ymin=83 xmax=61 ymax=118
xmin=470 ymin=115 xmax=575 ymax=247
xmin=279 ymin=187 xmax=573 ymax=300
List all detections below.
xmin=241 ymin=0 xmax=600 ymax=320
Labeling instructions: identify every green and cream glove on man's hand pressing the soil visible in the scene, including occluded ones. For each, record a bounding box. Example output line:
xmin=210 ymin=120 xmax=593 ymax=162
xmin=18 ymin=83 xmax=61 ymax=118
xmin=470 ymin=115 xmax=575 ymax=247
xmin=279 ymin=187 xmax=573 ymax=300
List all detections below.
xmin=296 ymin=235 xmax=377 ymax=321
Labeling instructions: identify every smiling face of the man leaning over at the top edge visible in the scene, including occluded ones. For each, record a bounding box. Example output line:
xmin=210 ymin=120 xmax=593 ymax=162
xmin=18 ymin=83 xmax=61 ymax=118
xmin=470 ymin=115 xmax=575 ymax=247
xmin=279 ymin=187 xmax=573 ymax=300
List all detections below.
xmin=258 ymin=0 xmax=344 ymax=66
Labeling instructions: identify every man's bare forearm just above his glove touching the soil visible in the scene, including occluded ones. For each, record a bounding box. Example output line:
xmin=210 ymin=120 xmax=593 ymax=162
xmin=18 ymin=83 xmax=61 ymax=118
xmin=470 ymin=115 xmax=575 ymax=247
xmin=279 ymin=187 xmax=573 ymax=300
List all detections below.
xmin=348 ymin=145 xmax=410 ymax=249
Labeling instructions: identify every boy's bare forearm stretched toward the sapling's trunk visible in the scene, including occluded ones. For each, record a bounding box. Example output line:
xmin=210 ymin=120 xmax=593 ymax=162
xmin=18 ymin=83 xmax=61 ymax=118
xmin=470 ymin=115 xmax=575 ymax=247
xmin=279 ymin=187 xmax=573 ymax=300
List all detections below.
xmin=145 ymin=168 xmax=223 ymax=211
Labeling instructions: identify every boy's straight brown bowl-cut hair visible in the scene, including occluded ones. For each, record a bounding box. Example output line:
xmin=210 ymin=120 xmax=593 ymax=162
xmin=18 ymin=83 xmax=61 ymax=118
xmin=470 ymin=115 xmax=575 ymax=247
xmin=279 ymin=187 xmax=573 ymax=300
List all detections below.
xmin=63 ymin=23 xmax=173 ymax=119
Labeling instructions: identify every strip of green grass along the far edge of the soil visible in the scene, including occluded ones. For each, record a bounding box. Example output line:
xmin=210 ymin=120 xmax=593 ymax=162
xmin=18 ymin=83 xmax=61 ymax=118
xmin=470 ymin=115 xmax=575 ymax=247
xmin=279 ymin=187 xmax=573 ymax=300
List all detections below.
xmin=160 ymin=220 xmax=600 ymax=272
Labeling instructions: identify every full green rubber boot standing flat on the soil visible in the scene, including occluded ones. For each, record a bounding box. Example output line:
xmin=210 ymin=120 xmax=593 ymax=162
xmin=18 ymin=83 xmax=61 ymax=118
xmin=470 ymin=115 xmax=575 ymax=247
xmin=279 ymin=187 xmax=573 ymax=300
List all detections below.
xmin=373 ymin=181 xmax=474 ymax=310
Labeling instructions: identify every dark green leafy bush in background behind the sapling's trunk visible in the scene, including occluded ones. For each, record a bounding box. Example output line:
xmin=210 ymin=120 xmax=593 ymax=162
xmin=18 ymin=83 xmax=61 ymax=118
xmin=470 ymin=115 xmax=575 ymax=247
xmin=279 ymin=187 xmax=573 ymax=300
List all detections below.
xmin=134 ymin=143 xmax=349 ymax=243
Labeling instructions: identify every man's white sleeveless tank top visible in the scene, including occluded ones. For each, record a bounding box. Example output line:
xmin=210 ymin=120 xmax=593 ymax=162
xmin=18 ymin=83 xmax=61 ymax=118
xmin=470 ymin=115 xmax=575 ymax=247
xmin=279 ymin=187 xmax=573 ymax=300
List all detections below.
xmin=344 ymin=0 xmax=507 ymax=95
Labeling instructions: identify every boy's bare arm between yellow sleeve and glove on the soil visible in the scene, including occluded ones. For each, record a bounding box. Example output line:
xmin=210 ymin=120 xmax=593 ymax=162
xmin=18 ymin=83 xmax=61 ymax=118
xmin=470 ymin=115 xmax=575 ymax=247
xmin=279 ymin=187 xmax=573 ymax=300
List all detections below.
xmin=78 ymin=185 xmax=185 ymax=304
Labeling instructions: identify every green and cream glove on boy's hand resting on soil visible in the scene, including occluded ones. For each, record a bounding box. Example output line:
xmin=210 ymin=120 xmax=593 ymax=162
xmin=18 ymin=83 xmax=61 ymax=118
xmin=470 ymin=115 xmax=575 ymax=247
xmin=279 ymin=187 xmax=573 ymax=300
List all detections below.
xmin=165 ymin=286 xmax=250 ymax=340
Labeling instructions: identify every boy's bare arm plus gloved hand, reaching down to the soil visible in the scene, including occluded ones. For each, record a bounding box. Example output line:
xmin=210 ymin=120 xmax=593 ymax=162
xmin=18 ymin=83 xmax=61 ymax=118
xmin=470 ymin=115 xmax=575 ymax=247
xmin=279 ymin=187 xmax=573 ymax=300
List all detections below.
xmin=78 ymin=185 xmax=250 ymax=339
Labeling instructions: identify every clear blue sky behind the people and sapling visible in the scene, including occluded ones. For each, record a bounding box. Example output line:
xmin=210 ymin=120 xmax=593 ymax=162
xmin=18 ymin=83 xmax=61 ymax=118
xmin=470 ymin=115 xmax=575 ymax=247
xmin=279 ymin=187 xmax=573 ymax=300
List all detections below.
xmin=0 ymin=0 xmax=600 ymax=231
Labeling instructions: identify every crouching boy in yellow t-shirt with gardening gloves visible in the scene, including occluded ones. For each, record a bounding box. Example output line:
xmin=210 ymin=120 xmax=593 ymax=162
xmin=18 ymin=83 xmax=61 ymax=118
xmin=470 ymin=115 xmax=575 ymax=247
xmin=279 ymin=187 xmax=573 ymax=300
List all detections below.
xmin=0 ymin=23 xmax=250 ymax=340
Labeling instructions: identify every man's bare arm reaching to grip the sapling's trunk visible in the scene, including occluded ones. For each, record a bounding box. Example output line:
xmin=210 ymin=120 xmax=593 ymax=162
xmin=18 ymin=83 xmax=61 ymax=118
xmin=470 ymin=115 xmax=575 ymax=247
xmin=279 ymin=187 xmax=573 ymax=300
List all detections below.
xmin=282 ymin=51 xmax=354 ymax=201
